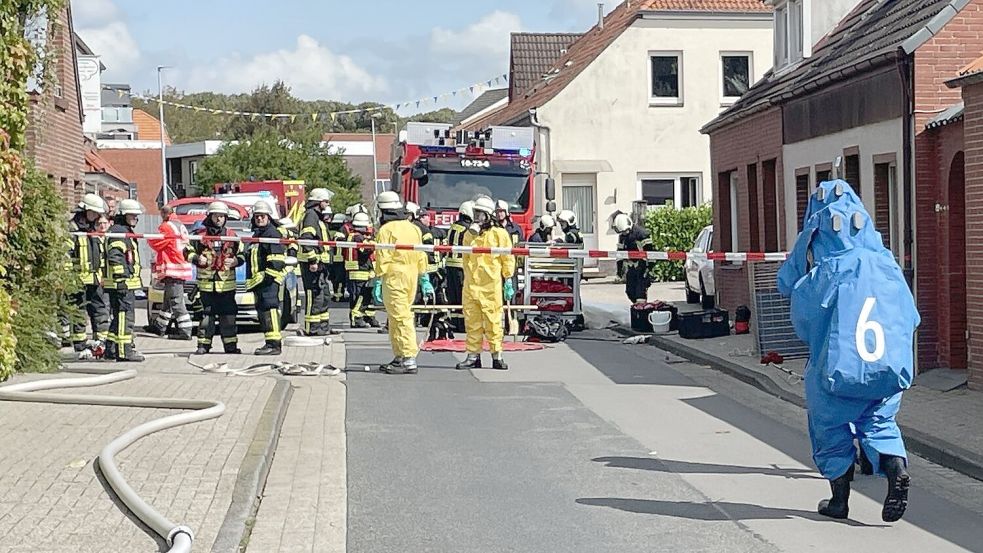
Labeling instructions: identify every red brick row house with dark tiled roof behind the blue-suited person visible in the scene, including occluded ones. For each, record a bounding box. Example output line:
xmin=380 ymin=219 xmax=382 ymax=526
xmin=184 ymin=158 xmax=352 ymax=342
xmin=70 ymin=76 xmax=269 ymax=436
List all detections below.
xmin=703 ymin=0 xmax=983 ymax=386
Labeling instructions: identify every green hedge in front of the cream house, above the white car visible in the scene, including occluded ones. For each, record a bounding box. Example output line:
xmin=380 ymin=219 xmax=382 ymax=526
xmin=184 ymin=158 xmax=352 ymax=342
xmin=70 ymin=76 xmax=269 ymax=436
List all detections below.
xmin=645 ymin=203 xmax=713 ymax=282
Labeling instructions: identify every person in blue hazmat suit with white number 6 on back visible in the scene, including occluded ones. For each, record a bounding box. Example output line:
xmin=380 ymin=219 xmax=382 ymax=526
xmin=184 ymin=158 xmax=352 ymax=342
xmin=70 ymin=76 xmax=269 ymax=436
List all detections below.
xmin=778 ymin=181 xmax=920 ymax=522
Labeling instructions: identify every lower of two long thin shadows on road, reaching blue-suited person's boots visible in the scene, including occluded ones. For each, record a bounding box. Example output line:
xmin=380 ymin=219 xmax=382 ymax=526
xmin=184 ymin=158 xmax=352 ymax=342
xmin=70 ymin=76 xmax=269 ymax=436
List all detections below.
xmin=577 ymin=497 xmax=889 ymax=528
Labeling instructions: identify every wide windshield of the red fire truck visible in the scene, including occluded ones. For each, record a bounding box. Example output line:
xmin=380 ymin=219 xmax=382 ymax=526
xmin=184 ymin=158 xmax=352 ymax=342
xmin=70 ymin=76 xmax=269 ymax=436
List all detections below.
xmin=418 ymin=159 xmax=529 ymax=212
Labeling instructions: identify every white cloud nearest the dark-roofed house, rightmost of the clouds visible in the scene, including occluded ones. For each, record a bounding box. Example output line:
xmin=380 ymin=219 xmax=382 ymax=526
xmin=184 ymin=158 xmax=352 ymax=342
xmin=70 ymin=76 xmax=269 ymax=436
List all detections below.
xmin=430 ymin=10 xmax=522 ymax=63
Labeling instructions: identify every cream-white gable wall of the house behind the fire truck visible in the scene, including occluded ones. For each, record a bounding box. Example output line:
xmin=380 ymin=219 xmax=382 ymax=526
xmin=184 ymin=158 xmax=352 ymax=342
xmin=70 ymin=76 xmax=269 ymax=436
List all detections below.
xmin=538 ymin=17 xmax=772 ymax=249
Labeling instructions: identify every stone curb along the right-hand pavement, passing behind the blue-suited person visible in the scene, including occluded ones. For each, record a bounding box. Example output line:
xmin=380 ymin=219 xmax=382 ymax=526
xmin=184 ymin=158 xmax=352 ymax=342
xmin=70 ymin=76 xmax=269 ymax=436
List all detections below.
xmin=640 ymin=327 xmax=983 ymax=480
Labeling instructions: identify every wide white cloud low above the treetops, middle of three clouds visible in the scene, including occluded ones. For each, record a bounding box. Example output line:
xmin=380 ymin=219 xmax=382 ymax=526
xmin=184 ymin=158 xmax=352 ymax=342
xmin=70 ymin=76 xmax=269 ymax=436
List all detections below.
xmin=181 ymin=35 xmax=387 ymax=100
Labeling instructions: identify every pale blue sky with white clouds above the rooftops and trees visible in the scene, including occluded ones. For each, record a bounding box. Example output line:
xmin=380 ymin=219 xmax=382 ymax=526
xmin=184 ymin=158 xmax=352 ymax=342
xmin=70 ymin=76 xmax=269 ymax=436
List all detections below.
xmin=71 ymin=0 xmax=620 ymax=111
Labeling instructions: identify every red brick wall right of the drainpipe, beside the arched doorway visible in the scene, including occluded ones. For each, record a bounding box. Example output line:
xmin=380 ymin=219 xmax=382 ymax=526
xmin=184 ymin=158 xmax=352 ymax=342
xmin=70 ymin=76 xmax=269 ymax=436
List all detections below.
xmin=914 ymin=0 xmax=983 ymax=368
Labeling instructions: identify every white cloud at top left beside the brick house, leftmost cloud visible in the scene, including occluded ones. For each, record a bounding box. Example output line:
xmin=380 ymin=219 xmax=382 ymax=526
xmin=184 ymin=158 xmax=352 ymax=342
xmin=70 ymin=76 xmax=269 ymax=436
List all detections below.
xmin=72 ymin=0 xmax=141 ymax=75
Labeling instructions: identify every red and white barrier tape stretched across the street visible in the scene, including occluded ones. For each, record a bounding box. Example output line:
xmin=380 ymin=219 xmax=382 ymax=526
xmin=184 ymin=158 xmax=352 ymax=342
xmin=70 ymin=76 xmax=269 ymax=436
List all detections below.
xmin=74 ymin=232 xmax=788 ymax=263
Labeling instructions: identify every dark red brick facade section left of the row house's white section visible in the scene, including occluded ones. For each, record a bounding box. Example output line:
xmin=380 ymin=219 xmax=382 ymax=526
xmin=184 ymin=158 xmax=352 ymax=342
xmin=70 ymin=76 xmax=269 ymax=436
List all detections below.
xmin=710 ymin=108 xmax=785 ymax=312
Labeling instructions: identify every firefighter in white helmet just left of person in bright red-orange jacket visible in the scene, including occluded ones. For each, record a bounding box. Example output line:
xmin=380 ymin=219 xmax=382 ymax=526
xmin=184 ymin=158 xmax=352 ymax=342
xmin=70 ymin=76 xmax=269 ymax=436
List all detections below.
xmin=105 ymin=200 xmax=144 ymax=362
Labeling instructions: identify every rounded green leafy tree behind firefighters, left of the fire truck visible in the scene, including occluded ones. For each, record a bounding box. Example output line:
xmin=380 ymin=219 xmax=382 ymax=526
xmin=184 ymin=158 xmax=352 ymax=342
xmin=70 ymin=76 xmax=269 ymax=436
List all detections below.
xmin=196 ymin=129 xmax=362 ymax=209
